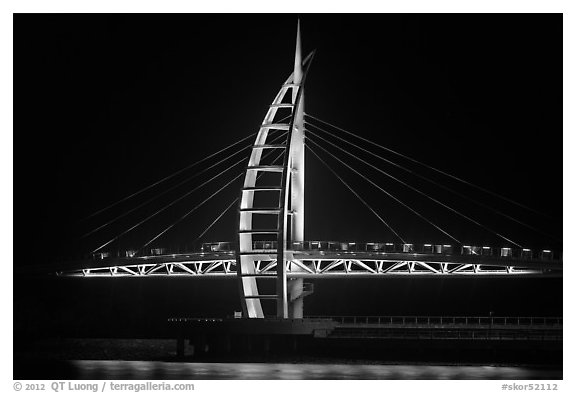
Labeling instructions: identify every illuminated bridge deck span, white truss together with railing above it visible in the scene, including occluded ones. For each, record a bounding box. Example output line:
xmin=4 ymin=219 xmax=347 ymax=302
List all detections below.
xmin=58 ymin=242 xmax=563 ymax=278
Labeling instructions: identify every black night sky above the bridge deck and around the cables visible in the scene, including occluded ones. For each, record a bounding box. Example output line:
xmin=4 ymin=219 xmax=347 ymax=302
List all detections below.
xmin=14 ymin=14 xmax=562 ymax=264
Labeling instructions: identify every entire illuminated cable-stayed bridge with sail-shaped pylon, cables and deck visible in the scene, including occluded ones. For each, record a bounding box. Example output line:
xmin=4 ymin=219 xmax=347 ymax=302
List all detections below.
xmin=51 ymin=20 xmax=562 ymax=319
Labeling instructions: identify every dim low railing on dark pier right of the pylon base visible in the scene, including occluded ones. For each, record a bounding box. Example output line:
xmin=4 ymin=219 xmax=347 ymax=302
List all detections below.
xmin=306 ymin=316 xmax=562 ymax=328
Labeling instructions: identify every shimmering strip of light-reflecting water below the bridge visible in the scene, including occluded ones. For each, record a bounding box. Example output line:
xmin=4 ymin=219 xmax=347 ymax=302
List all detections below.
xmin=71 ymin=360 xmax=562 ymax=380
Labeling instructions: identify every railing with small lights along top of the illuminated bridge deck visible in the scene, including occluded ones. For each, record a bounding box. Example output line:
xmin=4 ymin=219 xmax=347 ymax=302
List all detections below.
xmin=91 ymin=240 xmax=562 ymax=261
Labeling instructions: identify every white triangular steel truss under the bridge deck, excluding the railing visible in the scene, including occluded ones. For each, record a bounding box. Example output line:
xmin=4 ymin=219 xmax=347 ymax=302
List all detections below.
xmin=57 ymin=250 xmax=562 ymax=278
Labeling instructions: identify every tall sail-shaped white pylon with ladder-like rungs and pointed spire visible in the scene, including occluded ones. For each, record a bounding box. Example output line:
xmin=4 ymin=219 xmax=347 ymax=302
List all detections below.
xmin=236 ymin=21 xmax=314 ymax=318
